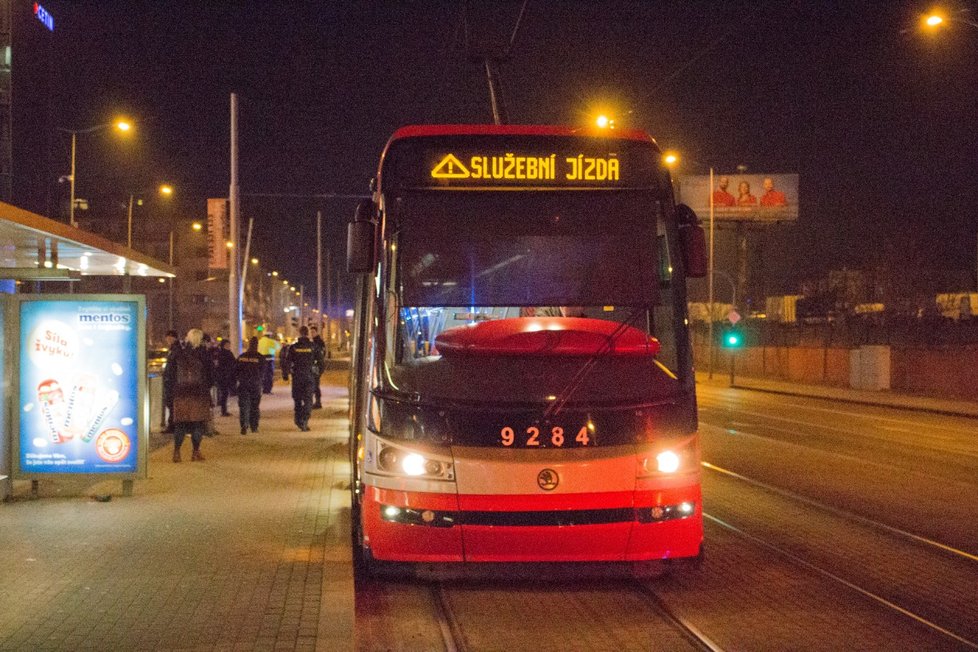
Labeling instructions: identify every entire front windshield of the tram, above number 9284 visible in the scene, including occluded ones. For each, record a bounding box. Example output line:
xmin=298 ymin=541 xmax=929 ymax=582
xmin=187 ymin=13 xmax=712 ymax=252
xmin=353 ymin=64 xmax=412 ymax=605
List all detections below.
xmin=385 ymin=190 xmax=677 ymax=405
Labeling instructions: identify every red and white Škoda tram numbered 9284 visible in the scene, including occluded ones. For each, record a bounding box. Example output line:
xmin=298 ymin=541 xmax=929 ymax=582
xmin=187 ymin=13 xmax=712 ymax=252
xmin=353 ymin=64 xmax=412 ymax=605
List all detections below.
xmin=347 ymin=125 xmax=705 ymax=568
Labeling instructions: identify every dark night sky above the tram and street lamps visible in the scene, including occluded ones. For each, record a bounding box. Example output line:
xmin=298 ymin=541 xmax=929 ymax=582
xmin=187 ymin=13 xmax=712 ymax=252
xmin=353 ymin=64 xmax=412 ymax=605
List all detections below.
xmin=42 ymin=0 xmax=978 ymax=304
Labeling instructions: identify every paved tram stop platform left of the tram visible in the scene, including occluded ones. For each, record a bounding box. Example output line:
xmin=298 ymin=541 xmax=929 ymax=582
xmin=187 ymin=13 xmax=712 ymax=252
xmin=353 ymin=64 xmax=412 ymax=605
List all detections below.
xmin=0 ymin=370 xmax=354 ymax=651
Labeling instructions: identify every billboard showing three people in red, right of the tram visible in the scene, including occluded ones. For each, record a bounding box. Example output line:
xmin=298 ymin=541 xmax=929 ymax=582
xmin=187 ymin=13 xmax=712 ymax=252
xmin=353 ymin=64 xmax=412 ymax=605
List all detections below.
xmin=677 ymin=172 xmax=798 ymax=222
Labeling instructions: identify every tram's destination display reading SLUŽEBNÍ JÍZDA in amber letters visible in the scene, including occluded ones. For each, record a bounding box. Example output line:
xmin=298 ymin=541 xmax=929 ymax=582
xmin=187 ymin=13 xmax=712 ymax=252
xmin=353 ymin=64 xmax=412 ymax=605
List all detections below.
xmin=388 ymin=138 xmax=661 ymax=189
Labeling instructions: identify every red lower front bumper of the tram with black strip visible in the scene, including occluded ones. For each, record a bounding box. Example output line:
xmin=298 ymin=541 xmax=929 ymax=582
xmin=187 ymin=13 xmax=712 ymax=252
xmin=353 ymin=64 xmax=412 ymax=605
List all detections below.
xmin=363 ymin=484 xmax=703 ymax=562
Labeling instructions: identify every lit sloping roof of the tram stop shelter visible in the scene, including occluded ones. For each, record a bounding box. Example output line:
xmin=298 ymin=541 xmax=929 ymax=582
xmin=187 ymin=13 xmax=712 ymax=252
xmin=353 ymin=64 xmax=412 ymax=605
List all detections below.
xmin=0 ymin=202 xmax=176 ymax=280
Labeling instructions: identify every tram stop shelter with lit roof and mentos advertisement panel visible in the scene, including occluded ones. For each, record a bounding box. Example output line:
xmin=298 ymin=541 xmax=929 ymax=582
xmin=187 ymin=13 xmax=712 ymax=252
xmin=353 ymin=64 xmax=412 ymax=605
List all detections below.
xmin=0 ymin=202 xmax=176 ymax=500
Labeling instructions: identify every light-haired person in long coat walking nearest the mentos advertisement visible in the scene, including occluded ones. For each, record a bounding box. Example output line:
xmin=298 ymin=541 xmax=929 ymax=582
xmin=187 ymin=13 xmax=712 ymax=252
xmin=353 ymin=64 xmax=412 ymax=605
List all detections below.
xmin=173 ymin=328 xmax=213 ymax=462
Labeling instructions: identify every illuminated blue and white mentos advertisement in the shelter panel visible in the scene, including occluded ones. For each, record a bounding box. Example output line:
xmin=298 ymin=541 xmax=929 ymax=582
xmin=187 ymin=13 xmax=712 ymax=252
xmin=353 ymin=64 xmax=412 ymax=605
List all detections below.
xmin=19 ymin=300 xmax=141 ymax=475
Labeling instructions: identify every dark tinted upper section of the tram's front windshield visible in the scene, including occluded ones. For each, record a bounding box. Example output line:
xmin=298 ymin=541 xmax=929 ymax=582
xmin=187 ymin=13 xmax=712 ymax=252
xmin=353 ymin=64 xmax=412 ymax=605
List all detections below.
xmin=393 ymin=191 xmax=657 ymax=306
